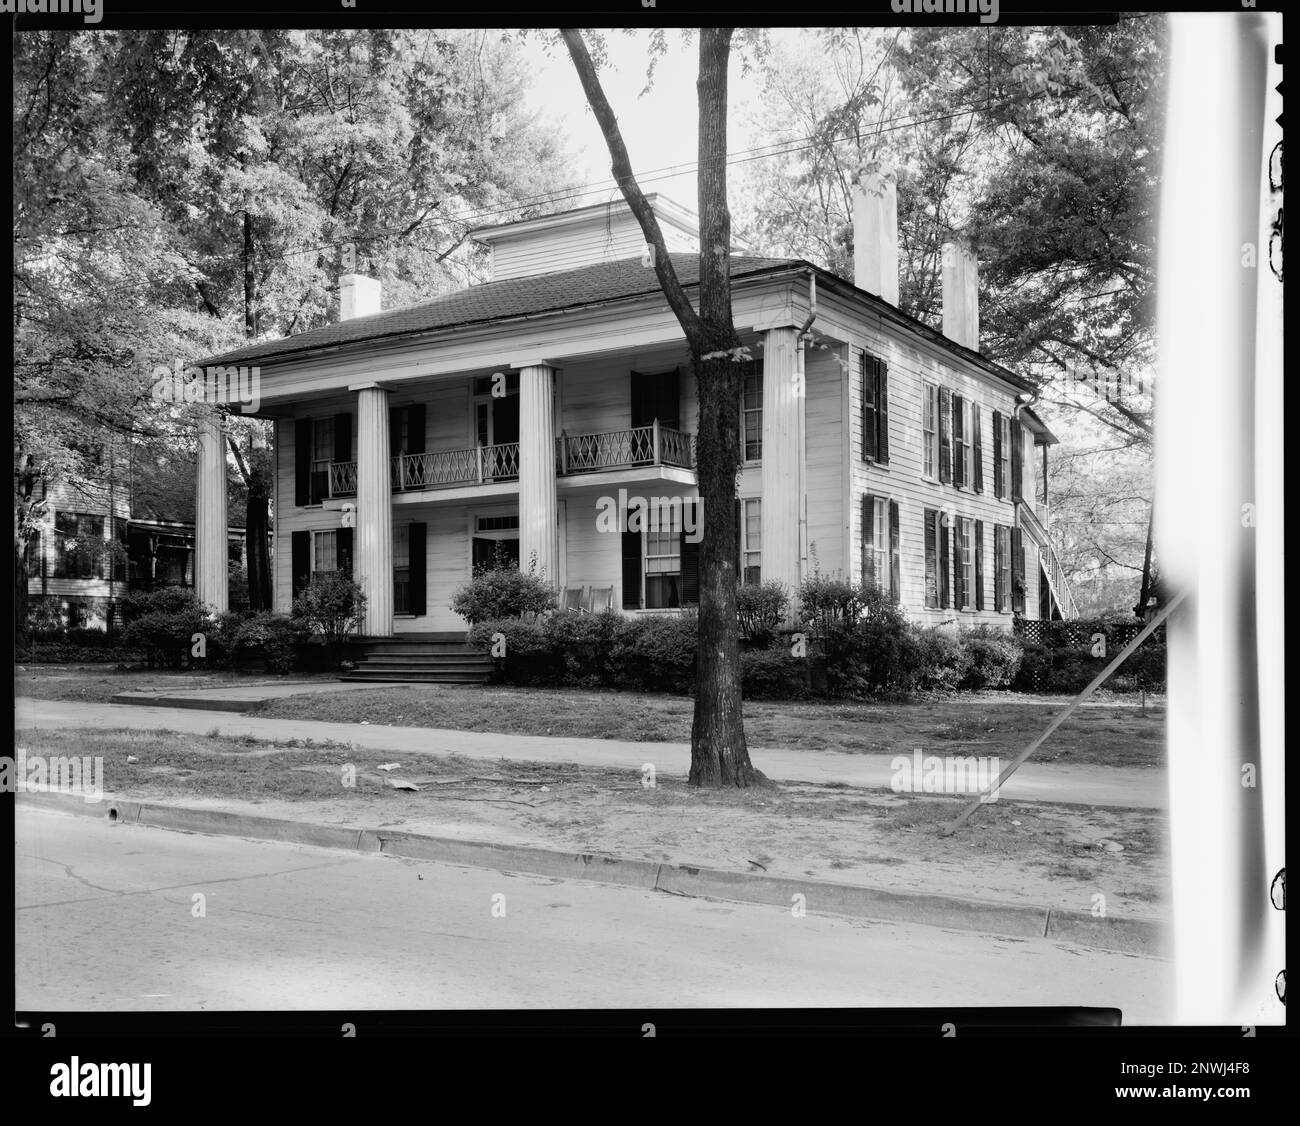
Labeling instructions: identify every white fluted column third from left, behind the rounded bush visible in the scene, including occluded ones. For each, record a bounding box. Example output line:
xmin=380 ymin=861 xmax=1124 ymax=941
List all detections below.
xmin=519 ymin=364 xmax=559 ymax=586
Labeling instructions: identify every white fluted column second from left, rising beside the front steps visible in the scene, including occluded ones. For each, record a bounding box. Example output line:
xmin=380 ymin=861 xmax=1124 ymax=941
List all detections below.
xmin=348 ymin=384 xmax=393 ymax=637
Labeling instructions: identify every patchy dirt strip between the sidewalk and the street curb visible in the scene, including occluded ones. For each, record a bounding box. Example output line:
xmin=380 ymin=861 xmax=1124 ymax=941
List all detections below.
xmin=18 ymin=731 xmax=1169 ymax=917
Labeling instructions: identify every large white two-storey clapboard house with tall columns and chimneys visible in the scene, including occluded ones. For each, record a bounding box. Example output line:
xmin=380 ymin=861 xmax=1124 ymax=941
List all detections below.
xmin=198 ymin=174 xmax=1073 ymax=637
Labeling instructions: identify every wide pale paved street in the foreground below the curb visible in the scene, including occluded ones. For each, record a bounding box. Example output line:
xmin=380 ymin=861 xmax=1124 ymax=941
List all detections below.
xmin=16 ymin=806 xmax=1173 ymax=1023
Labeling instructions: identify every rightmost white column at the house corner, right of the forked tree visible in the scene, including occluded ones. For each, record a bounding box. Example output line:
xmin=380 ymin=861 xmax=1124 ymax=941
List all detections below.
xmin=762 ymin=328 xmax=805 ymax=599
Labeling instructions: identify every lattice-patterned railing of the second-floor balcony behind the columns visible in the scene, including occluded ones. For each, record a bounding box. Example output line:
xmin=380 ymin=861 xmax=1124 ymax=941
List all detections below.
xmin=328 ymin=423 xmax=696 ymax=498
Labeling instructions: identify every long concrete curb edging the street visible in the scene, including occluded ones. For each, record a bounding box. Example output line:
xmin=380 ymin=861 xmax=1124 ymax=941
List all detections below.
xmin=21 ymin=793 xmax=1167 ymax=957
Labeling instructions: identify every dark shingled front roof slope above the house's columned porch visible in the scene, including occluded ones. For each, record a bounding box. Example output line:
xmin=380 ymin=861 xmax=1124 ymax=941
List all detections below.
xmin=204 ymin=254 xmax=797 ymax=365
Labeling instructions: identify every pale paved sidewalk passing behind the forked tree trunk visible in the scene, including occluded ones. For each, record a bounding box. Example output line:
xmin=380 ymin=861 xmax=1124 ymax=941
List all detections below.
xmin=14 ymin=697 xmax=1169 ymax=809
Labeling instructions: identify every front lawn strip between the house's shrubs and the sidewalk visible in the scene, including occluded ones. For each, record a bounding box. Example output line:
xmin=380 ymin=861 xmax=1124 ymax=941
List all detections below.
xmin=14 ymin=667 xmax=1165 ymax=767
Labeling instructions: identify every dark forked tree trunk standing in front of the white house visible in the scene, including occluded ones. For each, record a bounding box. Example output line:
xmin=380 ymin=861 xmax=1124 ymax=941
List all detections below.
xmin=562 ymin=27 xmax=766 ymax=788
